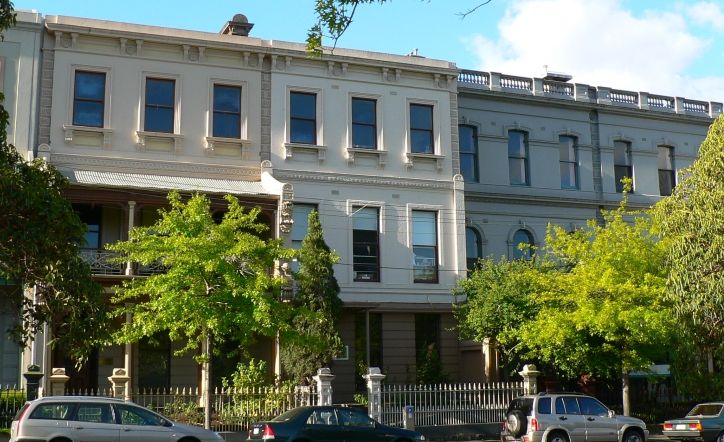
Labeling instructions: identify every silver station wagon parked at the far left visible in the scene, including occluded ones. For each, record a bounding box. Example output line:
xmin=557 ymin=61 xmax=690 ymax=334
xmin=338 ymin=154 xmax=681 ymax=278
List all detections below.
xmin=10 ymin=396 xmax=224 ymax=442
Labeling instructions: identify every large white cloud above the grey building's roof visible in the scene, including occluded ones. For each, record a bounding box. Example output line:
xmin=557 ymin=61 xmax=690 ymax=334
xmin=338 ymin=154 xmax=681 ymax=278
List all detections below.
xmin=467 ymin=0 xmax=724 ymax=101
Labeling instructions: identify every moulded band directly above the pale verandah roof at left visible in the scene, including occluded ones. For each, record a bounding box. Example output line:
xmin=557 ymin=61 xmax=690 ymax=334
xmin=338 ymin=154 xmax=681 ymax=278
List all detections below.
xmin=50 ymin=152 xmax=261 ymax=181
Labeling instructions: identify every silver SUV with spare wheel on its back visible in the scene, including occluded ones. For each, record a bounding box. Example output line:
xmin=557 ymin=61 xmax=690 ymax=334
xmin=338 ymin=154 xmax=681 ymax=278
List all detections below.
xmin=500 ymin=393 xmax=649 ymax=442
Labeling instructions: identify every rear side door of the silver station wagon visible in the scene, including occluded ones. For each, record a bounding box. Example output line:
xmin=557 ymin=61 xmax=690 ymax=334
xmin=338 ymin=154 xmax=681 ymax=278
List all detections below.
xmin=68 ymin=401 xmax=120 ymax=442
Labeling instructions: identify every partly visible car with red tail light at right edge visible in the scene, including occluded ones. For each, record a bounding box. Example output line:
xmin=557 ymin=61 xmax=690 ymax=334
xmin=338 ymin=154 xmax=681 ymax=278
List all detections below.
xmin=663 ymin=402 xmax=724 ymax=442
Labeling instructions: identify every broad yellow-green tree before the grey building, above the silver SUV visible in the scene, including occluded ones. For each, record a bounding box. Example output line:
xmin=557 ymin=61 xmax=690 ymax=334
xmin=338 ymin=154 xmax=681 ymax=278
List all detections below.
xmin=463 ymin=189 xmax=675 ymax=414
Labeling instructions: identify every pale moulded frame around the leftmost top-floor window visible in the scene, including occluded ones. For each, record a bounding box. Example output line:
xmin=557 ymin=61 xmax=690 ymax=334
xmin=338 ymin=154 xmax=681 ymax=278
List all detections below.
xmin=63 ymin=64 xmax=113 ymax=148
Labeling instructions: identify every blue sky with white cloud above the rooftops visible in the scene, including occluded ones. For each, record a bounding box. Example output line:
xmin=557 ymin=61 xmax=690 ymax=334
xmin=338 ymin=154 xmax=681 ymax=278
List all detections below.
xmin=14 ymin=0 xmax=724 ymax=102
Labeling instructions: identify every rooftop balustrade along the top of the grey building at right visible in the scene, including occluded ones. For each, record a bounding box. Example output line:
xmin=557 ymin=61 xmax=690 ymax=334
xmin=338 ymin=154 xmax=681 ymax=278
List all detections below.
xmin=458 ymin=69 xmax=724 ymax=118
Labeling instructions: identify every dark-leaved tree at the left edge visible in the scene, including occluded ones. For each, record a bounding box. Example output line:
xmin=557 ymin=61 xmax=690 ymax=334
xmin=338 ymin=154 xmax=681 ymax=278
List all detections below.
xmin=0 ymin=1 xmax=106 ymax=362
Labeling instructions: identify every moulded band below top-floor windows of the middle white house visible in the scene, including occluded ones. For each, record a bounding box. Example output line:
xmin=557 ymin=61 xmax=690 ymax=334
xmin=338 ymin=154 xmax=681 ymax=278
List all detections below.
xmin=274 ymin=169 xmax=453 ymax=190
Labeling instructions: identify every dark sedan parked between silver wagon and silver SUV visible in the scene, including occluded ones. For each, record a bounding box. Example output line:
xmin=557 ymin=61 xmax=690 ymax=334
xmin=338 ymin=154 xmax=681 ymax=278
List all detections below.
xmin=248 ymin=405 xmax=425 ymax=442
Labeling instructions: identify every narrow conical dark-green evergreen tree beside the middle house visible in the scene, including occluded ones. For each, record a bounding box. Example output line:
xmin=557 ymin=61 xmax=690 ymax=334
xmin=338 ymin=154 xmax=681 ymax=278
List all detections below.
xmin=281 ymin=210 xmax=342 ymax=383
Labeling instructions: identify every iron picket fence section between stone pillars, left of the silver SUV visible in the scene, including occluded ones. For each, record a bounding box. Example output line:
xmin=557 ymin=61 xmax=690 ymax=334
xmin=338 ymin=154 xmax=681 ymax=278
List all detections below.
xmin=381 ymin=382 xmax=523 ymax=427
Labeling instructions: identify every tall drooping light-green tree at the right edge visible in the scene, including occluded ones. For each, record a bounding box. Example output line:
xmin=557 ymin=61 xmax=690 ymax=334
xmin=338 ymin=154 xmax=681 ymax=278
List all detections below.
xmin=651 ymin=117 xmax=724 ymax=398
